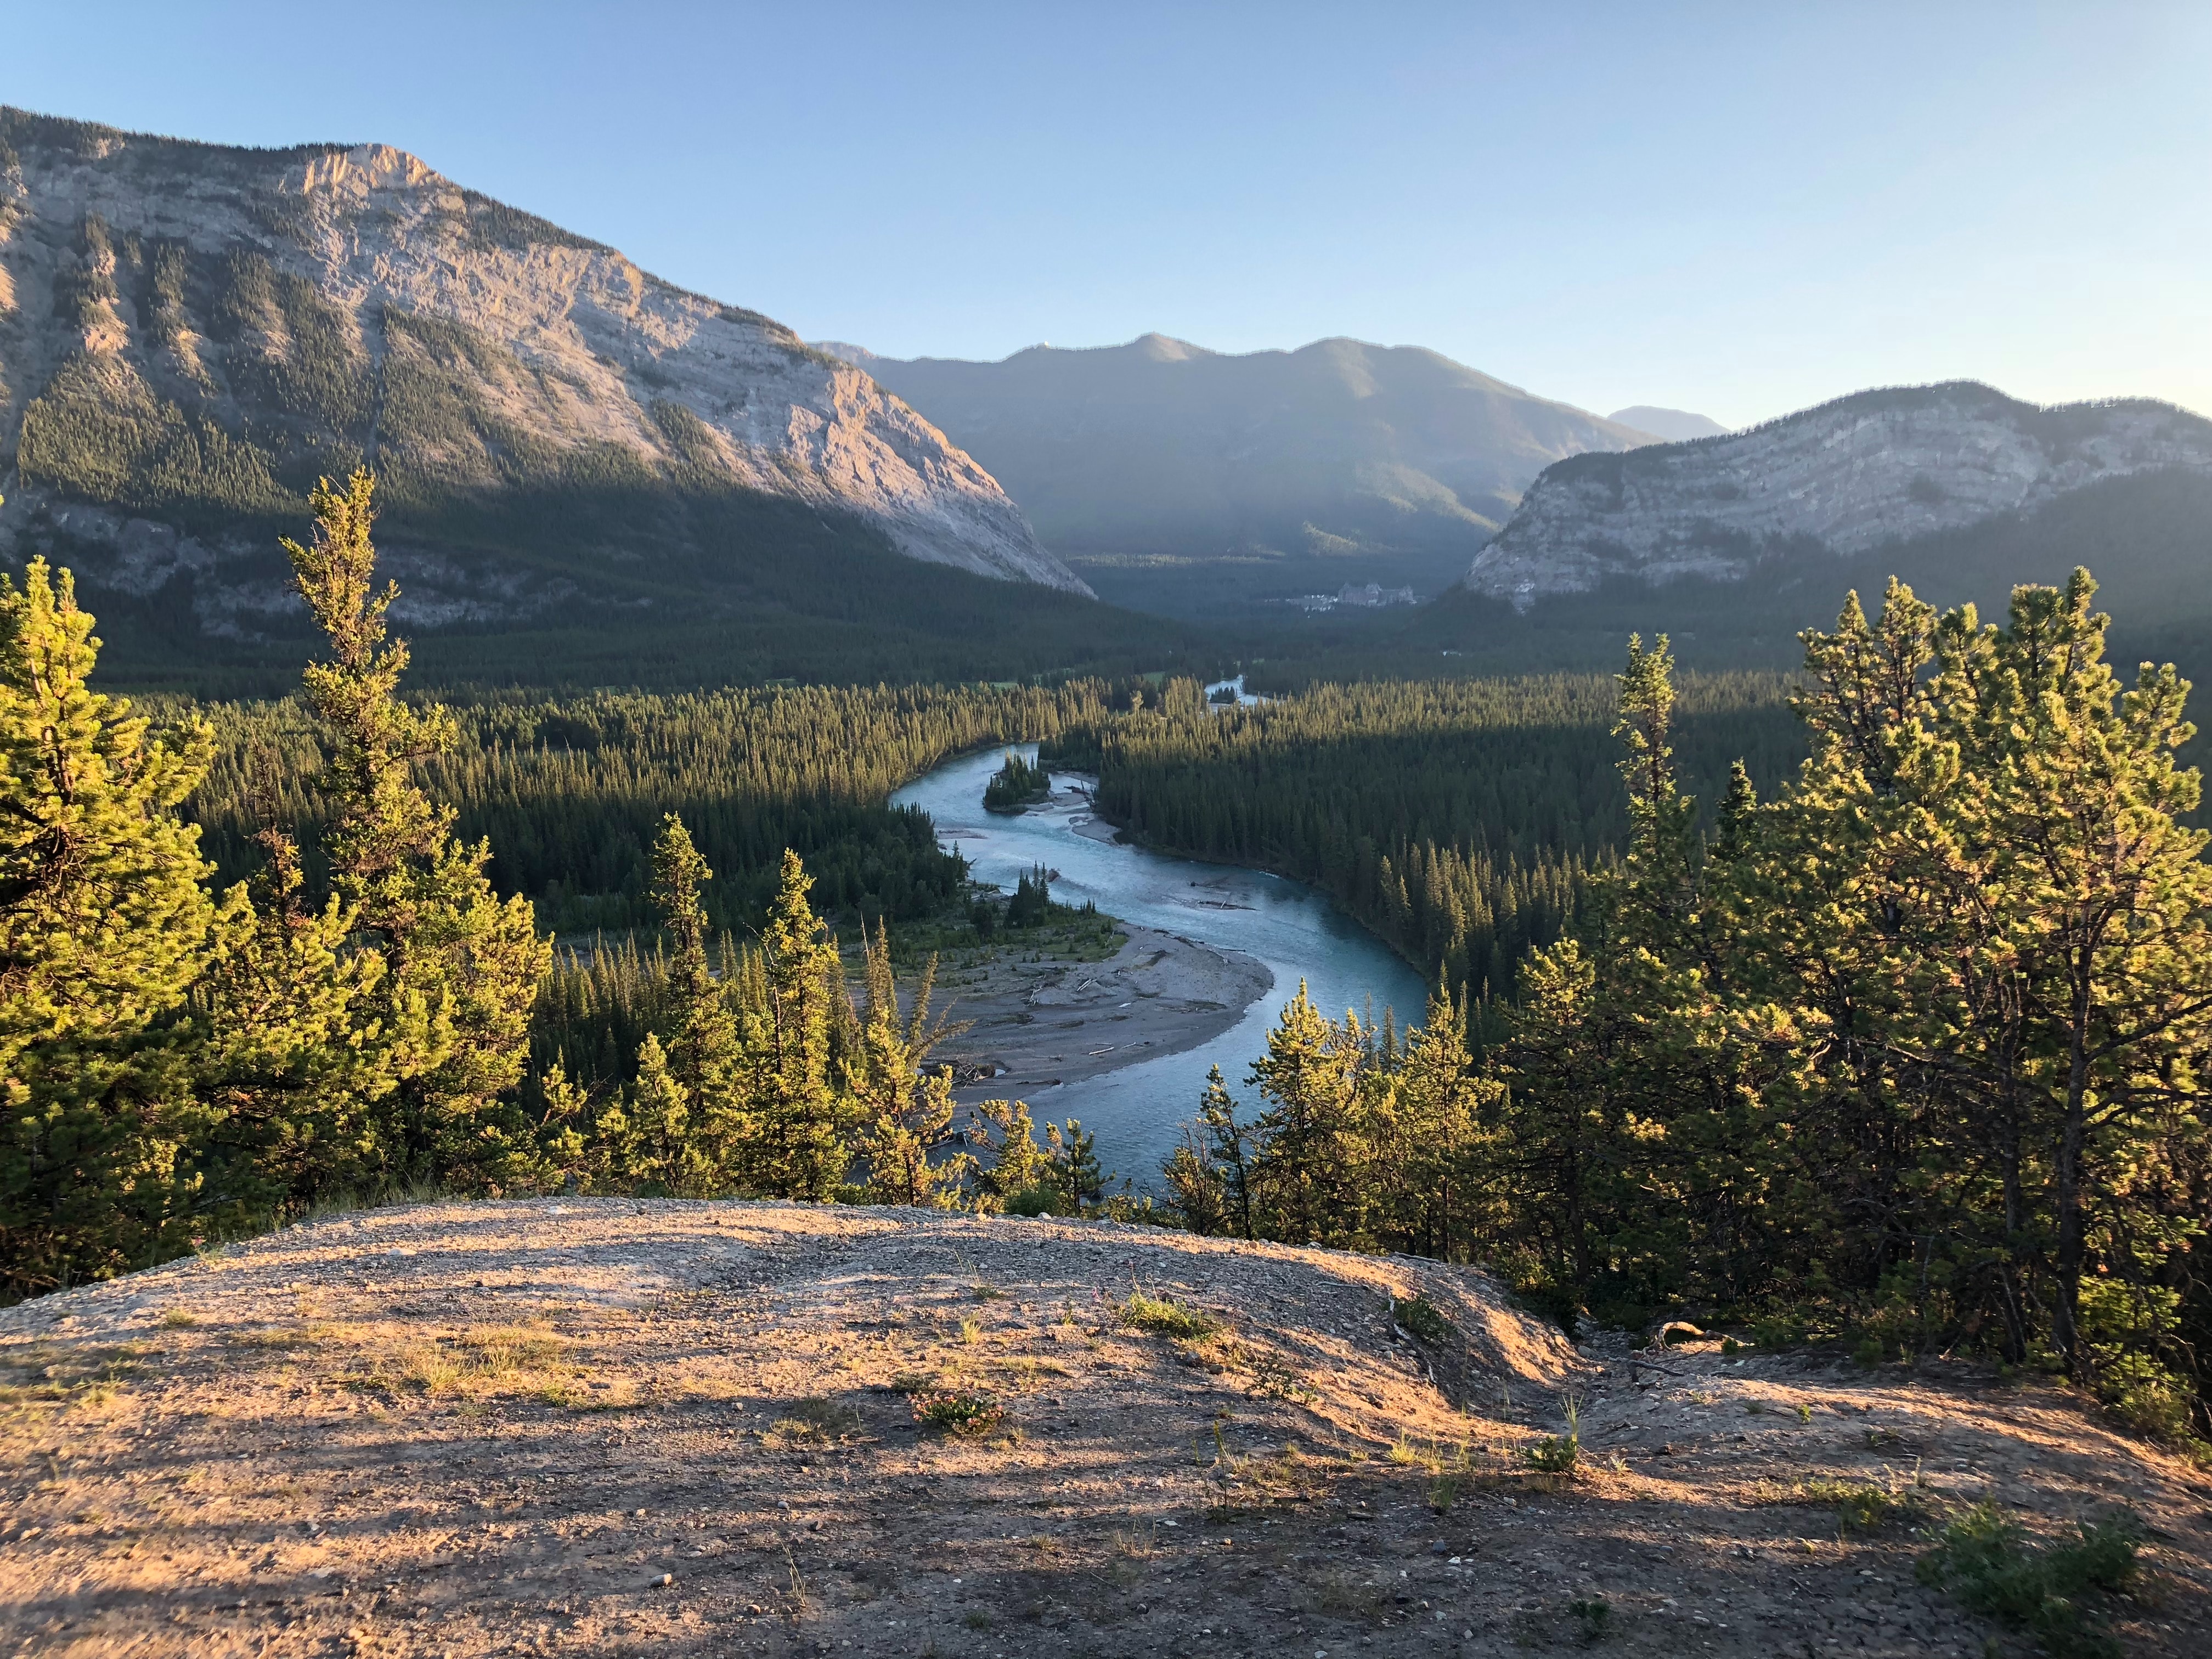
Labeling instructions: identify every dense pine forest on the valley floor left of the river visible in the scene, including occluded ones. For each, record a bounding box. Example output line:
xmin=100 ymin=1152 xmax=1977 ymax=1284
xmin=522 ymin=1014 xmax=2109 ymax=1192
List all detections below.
xmin=188 ymin=681 xmax=1126 ymax=934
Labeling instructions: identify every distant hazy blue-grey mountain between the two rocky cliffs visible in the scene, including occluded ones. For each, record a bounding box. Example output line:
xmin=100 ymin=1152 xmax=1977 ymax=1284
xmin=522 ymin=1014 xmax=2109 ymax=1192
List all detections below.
xmin=821 ymin=334 xmax=1652 ymax=611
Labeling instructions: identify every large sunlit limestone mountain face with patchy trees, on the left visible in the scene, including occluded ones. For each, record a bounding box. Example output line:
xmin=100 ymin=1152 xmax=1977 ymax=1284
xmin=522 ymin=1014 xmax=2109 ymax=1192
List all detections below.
xmin=0 ymin=111 xmax=1086 ymax=633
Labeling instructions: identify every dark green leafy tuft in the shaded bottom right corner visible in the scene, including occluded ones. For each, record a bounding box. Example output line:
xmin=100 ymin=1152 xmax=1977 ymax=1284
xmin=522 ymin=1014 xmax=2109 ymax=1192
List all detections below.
xmin=1914 ymin=1502 xmax=2143 ymax=1659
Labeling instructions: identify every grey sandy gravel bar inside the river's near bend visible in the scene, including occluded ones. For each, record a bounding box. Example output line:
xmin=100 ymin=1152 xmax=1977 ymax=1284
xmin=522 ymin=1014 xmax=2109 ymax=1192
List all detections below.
xmin=938 ymin=922 xmax=1274 ymax=1115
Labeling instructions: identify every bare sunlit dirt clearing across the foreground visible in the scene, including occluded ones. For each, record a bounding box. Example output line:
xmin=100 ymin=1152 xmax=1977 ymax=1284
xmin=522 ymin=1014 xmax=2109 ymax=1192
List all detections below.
xmin=0 ymin=1199 xmax=2212 ymax=1659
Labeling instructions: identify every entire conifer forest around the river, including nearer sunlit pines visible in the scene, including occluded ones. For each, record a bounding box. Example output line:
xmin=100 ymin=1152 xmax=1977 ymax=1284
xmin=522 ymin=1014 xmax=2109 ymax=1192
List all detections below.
xmin=0 ymin=473 xmax=2212 ymax=1436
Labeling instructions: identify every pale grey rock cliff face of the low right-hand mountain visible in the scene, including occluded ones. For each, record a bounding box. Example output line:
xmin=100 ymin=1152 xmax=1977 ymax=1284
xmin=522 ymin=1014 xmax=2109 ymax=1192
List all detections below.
xmin=1466 ymin=383 xmax=2212 ymax=608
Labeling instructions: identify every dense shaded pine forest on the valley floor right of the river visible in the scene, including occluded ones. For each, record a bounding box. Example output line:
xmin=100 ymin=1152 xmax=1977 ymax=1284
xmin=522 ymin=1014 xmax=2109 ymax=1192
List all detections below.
xmin=1042 ymin=675 xmax=1805 ymax=1033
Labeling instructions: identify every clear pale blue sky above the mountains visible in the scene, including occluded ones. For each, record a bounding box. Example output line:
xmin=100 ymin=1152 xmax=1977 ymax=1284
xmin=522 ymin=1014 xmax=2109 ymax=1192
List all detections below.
xmin=0 ymin=0 xmax=2212 ymax=422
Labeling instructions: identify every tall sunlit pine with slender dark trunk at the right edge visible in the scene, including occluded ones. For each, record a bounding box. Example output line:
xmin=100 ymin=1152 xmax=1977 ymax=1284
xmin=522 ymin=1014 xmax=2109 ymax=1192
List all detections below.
xmin=1936 ymin=571 xmax=2212 ymax=1383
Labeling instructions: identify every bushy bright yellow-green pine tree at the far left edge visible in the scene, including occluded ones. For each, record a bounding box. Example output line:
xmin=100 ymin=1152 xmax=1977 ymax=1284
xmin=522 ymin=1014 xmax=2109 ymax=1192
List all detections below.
xmin=0 ymin=560 xmax=220 ymax=1292
